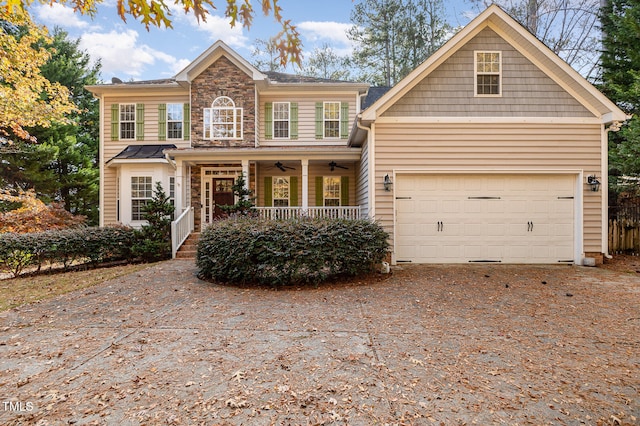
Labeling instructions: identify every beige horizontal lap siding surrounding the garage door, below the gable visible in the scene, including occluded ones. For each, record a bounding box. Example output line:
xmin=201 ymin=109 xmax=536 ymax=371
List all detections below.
xmin=372 ymin=123 xmax=603 ymax=252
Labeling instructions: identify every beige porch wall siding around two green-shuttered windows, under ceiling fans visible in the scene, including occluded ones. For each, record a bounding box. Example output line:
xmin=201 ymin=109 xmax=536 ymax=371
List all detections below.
xmin=257 ymin=159 xmax=358 ymax=207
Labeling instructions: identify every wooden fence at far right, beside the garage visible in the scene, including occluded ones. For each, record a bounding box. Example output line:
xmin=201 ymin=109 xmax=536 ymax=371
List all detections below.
xmin=609 ymin=197 xmax=640 ymax=256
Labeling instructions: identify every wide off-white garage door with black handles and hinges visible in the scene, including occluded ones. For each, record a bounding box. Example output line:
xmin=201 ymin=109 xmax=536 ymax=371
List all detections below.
xmin=395 ymin=174 xmax=575 ymax=263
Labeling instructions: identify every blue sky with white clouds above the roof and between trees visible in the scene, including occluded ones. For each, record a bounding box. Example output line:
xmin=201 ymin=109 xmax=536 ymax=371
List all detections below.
xmin=32 ymin=0 xmax=473 ymax=82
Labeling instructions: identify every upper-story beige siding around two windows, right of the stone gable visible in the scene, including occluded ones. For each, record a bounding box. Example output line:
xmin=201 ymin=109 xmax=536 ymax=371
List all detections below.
xmin=258 ymin=92 xmax=357 ymax=146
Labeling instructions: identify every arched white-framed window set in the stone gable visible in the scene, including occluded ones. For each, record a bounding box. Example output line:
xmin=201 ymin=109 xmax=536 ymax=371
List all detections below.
xmin=203 ymin=96 xmax=242 ymax=139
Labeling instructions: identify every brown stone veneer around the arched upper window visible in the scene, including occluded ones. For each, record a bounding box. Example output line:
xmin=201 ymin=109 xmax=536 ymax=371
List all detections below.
xmin=191 ymin=56 xmax=256 ymax=148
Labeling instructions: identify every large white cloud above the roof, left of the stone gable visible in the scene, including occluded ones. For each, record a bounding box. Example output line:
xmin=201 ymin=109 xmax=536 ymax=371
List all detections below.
xmin=80 ymin=30 xmax=189 ymax=80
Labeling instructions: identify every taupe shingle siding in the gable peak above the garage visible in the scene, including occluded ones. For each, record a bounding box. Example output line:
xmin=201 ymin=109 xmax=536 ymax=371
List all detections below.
xmin=383 ymin=28 xmax=594 ymax=118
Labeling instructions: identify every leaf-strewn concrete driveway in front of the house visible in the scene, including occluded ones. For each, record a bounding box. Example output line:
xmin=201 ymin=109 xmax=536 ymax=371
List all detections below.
xmin=0 ymin=260 xmax=640 ymax=425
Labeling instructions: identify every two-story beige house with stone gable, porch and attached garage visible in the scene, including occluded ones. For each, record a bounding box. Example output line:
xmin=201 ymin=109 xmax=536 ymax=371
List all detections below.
xmin=89 ymin=6 xmax=627 ymax=264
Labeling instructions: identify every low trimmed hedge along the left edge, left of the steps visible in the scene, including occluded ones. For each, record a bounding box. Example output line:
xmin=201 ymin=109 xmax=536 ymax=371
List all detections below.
xmin=0 ymin=227 xmax=138 ymax=276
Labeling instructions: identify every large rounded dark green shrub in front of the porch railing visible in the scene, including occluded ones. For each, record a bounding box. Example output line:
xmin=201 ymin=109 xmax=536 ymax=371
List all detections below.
xmin=196 ymin=217 xmax=389 ymax=287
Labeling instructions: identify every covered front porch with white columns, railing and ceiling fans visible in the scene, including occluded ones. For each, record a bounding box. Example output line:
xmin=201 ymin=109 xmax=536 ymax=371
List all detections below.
xmin=165 ymin=147 xmax=366 ymax=255
